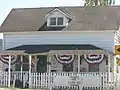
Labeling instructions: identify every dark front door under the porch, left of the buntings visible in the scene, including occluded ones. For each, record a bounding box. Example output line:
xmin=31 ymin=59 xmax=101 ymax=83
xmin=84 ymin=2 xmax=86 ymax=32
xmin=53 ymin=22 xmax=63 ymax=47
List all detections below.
xmin=37 ymin=55 xmax=47 ymax=73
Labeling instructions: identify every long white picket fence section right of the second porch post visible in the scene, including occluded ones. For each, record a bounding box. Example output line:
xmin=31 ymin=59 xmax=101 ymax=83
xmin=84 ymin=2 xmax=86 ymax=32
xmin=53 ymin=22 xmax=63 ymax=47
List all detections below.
xmin=30 ymin=72 xmax=116 ymax=90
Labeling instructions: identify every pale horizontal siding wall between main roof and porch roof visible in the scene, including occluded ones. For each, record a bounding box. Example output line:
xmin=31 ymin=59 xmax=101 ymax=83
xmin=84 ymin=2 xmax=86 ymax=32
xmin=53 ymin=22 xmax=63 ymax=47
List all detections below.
xmin=4 ymin=32 xmax=114 ymax=51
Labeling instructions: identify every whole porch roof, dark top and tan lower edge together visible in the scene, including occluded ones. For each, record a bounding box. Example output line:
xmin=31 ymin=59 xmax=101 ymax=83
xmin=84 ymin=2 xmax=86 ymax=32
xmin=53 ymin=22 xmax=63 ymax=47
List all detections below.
xmin=0 ymin=44 xmax=112 ymax=55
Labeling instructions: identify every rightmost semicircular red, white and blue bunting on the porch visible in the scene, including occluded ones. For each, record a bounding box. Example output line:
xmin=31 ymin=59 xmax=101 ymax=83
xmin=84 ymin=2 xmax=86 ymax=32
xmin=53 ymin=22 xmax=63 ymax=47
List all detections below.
xmin=84 ymin=54 xmax=104 ymax=64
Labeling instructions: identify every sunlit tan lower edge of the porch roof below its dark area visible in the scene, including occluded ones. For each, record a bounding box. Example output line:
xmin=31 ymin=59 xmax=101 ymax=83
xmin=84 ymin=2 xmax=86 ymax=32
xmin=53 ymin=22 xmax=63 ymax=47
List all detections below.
xmin=0 ymin=50 xmax=114 ymax=55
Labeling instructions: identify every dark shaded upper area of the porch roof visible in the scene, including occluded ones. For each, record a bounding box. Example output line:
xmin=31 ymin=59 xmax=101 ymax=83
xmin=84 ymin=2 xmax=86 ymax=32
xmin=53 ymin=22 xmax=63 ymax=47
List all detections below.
xmin=7 ymin=44 xmax=102 ymax=53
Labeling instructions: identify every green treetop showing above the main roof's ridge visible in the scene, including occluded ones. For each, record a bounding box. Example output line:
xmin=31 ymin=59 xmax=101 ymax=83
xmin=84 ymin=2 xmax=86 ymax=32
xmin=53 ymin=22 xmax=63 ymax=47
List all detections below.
xmin=84 ymin=0 xmax=115 ymax=6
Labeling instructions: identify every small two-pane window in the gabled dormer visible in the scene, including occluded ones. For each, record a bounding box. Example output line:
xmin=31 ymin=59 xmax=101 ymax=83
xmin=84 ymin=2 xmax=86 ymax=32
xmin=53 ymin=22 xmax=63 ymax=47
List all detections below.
xmin=50 ymin=17 xmax=64 ymax=26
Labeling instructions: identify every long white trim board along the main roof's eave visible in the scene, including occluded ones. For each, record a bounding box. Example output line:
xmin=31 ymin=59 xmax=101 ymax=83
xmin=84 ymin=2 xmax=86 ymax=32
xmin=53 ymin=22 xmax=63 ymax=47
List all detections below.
xmin=4 ymin=29 xmax=115 ymax=35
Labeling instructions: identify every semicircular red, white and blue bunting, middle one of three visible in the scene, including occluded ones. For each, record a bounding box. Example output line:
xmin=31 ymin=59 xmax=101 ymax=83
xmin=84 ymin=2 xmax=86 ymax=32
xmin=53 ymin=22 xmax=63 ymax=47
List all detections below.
xmin=55 ymin=54 xmax=75 ymax=64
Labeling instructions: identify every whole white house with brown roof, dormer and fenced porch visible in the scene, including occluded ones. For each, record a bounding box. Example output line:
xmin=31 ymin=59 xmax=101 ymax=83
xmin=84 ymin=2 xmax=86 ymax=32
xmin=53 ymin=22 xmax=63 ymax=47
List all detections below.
xmin=0 ymin=6 xmax=120 ymax=90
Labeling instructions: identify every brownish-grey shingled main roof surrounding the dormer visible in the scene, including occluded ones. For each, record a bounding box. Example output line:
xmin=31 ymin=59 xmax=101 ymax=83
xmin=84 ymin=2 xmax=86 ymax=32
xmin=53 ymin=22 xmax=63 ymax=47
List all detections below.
xmin=0 ymin=6 xmax=120 ymax=32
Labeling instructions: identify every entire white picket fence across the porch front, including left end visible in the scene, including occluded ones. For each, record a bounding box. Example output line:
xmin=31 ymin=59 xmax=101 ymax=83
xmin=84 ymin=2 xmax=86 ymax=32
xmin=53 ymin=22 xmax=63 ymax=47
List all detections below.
xmin=0 ymin=72 xmax=120 ymax=90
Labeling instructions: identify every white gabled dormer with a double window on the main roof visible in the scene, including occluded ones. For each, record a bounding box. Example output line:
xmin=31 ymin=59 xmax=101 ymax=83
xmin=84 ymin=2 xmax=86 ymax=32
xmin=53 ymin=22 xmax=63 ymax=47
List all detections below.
xmin=45 ymin=8 xmax=72 ymax=27
